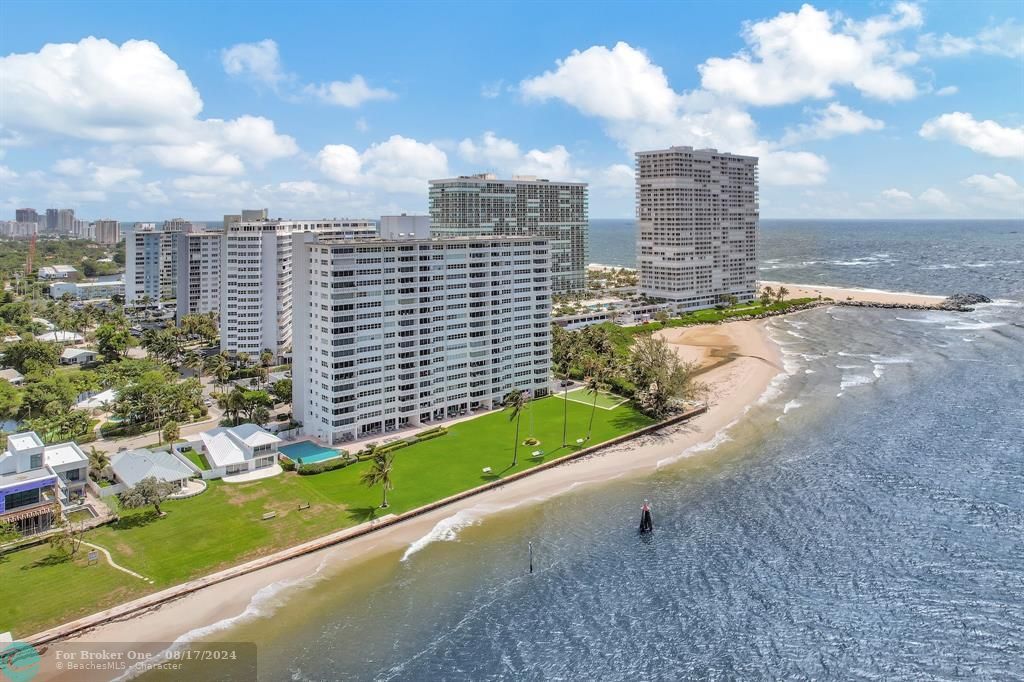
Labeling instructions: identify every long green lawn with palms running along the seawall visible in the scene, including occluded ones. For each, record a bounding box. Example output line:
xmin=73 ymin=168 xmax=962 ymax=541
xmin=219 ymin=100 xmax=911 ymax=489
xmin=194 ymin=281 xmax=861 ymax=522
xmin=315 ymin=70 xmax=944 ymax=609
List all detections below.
xmin=0 ymin=397 xmax=652 ymax=635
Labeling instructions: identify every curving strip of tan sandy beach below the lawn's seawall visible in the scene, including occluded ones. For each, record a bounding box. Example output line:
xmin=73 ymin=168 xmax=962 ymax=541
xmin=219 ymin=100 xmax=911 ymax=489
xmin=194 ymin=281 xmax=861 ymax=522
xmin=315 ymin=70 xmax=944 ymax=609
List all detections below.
xmin=39 ymin=321 xmax=780 ymax=679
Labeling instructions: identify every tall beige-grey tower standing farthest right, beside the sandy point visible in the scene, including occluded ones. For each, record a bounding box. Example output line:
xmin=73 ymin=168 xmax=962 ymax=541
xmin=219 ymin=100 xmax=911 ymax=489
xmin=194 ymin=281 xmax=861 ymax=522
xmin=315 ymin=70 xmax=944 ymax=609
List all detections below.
xmin=636 ymin=146 xmax=758 ymax=309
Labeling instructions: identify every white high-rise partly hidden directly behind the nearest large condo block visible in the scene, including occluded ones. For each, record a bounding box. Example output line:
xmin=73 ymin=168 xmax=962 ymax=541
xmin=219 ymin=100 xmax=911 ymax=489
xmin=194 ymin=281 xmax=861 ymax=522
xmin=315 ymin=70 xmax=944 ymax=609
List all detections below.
xmin=220 ymin=218 xmax=377 ymax=355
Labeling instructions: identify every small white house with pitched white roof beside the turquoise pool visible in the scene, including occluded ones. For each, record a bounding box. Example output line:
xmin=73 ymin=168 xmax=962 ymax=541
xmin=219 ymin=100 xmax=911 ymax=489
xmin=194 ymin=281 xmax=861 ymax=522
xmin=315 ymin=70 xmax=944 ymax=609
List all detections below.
xmin=175 ymin=424 xmax=283 ymax=478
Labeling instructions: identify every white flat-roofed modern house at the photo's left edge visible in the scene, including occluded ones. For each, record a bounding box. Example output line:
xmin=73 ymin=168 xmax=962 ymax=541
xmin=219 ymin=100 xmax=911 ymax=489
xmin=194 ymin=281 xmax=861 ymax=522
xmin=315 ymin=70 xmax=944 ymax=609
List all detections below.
xmin=0 ymin=431 xmax=89 ymax=536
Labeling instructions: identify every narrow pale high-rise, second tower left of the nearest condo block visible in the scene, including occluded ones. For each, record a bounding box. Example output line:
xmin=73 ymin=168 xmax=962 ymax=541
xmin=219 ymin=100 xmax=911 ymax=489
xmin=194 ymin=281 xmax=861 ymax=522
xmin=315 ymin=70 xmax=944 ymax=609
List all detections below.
xmin=175 ymin=230 xmax=224 ymax=323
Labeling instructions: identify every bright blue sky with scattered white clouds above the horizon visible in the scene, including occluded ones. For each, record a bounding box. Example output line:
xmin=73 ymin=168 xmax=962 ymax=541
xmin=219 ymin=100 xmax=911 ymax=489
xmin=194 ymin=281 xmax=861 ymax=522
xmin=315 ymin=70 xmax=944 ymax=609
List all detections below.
xmin=0 ymin=0 xmax=1024 ymax=220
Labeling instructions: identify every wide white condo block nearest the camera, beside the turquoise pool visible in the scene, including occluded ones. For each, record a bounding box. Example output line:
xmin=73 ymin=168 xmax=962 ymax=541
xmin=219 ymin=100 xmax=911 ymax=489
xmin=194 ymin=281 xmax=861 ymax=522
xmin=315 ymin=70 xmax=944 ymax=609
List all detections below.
xmin=292 ymin=236 xmax=551 ymax=444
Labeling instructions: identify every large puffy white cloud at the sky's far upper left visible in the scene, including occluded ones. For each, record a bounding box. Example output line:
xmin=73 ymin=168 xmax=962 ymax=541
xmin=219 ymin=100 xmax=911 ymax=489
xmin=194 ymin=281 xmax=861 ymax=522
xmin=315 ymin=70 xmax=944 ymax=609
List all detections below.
xmin=0 ymin=37 xmax=298 ymax=174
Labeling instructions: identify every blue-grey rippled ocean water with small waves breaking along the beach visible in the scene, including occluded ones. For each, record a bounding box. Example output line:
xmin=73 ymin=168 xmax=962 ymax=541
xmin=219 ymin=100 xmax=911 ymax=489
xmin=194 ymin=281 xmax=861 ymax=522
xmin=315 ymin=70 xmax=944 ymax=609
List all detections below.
xmin=146 ymin=223 xmax=1024 ymax=681
